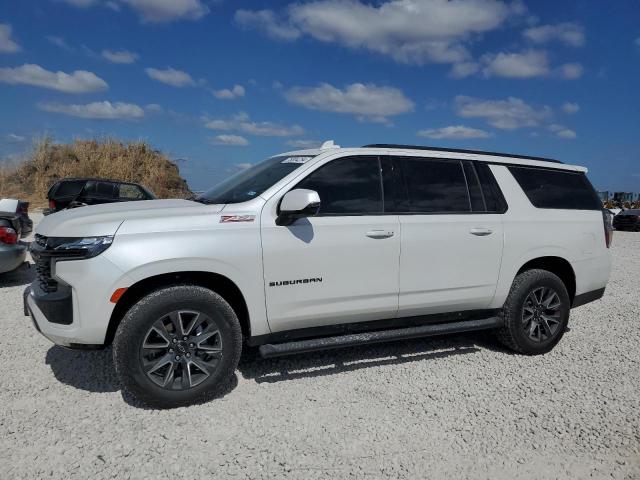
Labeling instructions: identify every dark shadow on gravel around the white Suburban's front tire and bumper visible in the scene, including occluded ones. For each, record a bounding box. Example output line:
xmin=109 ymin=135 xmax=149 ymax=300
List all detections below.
xmin=45 ymin=345 xmax=238 ymax=410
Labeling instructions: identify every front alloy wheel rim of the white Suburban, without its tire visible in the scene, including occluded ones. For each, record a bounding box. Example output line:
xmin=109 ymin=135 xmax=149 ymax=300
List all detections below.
xmin=140 ymin=310 xmax=223 ymax=390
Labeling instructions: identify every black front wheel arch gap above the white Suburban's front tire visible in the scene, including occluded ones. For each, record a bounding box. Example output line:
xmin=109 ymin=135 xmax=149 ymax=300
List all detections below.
xmin=104 ymin=271 xmax=251 ymax=346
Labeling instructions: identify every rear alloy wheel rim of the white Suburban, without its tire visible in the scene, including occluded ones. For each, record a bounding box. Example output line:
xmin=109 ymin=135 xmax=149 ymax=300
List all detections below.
xmin=522 ymin=287 xmax=562 ymax=343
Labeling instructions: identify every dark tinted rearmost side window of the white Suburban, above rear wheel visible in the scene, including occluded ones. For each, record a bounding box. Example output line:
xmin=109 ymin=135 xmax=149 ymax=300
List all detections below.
xmin=509 ymin=166 xmax=602 ymax=210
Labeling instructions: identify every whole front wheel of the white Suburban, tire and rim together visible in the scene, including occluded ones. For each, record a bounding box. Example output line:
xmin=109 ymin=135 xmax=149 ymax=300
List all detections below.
xmin=113 ymin=285 xmax=242 ymax=408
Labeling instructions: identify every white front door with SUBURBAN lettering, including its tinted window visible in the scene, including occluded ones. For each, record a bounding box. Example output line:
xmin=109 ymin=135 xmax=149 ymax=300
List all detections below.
xmin=261 ymin=157 xmax=400 ymax=332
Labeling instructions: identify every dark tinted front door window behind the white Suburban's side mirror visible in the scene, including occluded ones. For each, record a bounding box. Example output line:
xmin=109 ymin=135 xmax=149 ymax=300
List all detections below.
xmin=295 ymin=157 xmax=384 ymax=215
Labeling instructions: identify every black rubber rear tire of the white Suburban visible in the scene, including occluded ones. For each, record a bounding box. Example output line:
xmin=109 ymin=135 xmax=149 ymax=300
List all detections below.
xmin=497 ymin=269 xmax=571 ymax=355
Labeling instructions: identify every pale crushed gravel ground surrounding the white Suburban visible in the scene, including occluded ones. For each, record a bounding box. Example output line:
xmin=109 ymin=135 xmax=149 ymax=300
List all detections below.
xmin=0 ymin=215 xmax=640 ymax=479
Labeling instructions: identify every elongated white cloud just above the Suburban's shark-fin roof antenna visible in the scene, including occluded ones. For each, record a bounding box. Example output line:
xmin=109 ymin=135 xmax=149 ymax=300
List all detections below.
xmin=284 ymin=83 xmax=414 ymax=122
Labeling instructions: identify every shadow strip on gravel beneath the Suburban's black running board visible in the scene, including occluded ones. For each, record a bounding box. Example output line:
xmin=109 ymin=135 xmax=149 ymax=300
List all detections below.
xmin=238 ymin=332 xmax=504 ymax=383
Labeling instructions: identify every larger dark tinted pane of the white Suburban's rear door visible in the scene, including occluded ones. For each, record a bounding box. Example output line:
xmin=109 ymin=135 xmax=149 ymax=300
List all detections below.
xmin=398 ymin=157 xmax=471 ymax=213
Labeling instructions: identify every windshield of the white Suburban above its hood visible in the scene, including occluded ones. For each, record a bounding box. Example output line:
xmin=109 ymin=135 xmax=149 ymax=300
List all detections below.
xmin=195 ymin=155 xmax=313 ymax=203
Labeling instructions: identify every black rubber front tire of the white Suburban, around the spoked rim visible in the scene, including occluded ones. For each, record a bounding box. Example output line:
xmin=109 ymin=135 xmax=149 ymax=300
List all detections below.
xmin=113 ymin=285 xmax=242 ymax=408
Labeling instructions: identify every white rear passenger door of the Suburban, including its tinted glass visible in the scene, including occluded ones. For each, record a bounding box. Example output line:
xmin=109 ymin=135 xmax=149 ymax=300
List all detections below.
xmin=393 ymin=157 xmax=505 ymax=316
